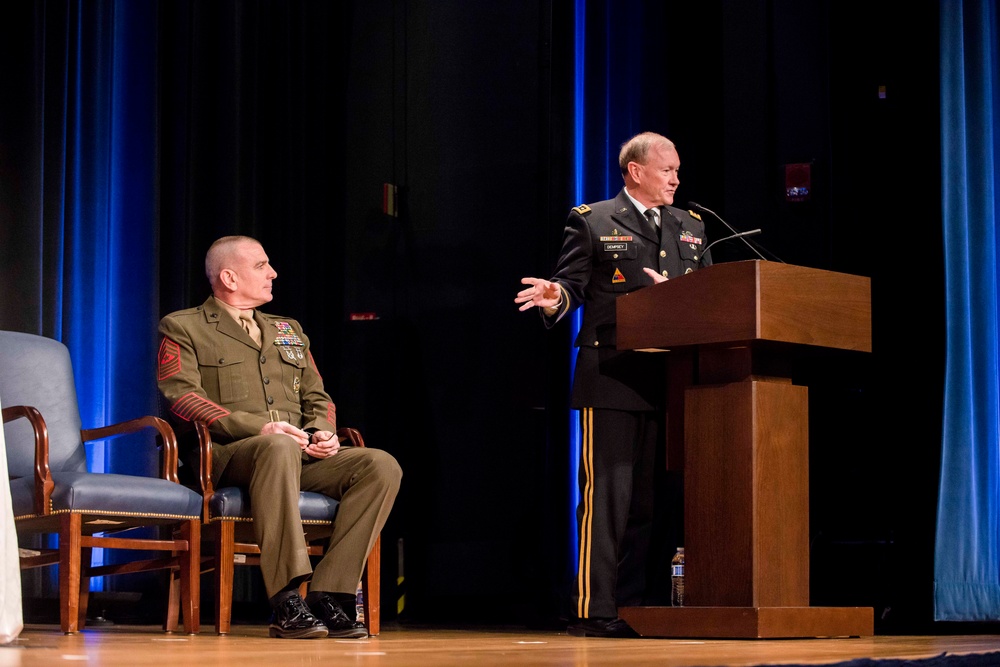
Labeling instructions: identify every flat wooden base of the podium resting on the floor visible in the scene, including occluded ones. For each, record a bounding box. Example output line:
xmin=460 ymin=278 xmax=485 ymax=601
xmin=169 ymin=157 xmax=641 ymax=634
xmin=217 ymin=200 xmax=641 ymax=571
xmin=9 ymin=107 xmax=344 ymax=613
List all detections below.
xmin=618 ymin=607 xmax=875 ymax=639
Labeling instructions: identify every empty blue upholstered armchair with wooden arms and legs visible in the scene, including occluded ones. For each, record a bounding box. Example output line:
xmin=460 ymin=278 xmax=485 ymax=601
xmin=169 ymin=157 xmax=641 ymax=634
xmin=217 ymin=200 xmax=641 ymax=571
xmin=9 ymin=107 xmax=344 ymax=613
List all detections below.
xmin=0 ymin=331 xmax=202 ymax=634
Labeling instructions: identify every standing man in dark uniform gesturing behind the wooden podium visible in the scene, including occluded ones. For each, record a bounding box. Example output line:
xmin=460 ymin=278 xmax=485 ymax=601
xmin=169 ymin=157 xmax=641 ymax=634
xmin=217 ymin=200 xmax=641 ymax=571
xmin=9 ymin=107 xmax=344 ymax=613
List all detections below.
xmin=515 ymin=132 xmax=711 ymax=637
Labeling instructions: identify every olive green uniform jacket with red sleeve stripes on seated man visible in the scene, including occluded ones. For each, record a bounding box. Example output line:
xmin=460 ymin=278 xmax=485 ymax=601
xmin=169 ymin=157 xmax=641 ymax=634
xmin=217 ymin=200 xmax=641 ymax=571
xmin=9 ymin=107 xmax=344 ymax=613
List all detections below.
xmin=157 ymin=297 xmax=337 ymax=481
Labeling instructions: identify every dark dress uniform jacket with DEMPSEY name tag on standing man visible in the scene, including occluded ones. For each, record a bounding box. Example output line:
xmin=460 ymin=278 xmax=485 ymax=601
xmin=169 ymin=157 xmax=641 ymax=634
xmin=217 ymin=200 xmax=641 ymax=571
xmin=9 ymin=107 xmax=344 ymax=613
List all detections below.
xmin=542 ymin=185 xmax=712 ymax=410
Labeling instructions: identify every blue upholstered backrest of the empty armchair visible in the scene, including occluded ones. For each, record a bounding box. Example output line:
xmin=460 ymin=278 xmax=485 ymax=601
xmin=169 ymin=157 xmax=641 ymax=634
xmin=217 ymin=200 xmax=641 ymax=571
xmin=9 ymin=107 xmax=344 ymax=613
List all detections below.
xmin=0 ymin=331 xmax=87 ymax=477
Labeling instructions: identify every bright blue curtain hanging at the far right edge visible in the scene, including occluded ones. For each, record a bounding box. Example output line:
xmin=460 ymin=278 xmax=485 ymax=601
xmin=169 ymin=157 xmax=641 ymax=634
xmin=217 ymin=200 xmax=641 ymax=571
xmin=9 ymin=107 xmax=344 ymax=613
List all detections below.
xmin=932 ymin=0 xmax=1000 ymax=621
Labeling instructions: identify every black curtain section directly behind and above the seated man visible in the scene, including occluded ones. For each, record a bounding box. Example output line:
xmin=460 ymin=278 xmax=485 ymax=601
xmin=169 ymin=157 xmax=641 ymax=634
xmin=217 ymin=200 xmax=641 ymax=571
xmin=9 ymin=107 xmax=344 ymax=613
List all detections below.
xmin=158 ymin=1 xmax=354 ymax=382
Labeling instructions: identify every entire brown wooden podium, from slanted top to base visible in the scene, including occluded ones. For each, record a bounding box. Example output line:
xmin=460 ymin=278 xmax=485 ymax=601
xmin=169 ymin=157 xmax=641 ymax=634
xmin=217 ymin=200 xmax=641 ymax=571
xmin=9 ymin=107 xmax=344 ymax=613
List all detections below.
xmin=617 ymin=260 xmax=874 ymax=638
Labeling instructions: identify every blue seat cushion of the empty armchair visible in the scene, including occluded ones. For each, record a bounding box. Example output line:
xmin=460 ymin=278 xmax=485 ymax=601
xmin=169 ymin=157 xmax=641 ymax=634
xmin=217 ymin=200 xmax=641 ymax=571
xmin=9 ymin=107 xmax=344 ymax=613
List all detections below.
xmin=10 ymin=472 xmax=202 ymax=519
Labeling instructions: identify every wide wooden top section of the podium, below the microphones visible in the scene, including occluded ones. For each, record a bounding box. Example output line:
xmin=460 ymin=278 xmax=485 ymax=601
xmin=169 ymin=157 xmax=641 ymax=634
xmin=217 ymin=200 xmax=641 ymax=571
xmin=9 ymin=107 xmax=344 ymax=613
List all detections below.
xmin=616 ymin=260 xmax=872 ymax=352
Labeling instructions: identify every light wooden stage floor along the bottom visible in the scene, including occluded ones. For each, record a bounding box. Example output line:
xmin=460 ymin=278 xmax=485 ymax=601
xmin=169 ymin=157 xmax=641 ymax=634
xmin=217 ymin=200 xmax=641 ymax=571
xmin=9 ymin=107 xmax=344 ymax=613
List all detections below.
xmin=0 ymin=625 xmax=1000 ymax=667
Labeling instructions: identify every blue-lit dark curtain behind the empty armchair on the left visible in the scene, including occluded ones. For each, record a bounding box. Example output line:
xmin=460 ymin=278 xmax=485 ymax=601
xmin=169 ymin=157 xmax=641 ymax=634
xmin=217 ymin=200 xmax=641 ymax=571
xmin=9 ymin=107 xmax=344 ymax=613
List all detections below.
xmin=0 ymin=0 xmax=159 ymax=474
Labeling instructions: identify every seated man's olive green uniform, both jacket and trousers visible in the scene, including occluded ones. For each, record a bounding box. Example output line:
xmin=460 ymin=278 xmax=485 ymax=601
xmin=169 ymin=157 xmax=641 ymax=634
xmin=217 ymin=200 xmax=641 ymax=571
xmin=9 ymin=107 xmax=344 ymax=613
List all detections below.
xmin=157 ymin=297 xmax=401 ymax=597
